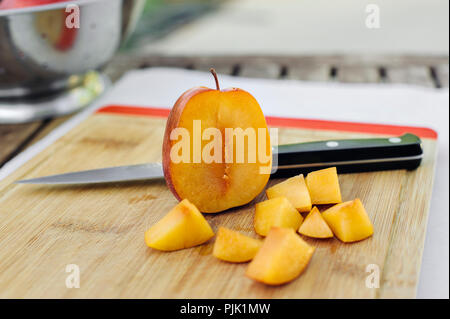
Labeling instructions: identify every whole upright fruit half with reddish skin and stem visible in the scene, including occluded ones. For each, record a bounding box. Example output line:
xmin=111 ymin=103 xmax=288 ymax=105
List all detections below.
xmin=162 ymin=70 xmax=272 ymax=213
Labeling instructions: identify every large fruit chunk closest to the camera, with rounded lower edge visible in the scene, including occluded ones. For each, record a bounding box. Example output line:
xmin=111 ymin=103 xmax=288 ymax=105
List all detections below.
xmin=245 ymin=227 xmax=315 ymax=285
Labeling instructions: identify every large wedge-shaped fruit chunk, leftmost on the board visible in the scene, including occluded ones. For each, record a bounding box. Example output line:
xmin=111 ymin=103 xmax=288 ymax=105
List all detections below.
xmin=145 ymin=199 xmax=214 ymax=251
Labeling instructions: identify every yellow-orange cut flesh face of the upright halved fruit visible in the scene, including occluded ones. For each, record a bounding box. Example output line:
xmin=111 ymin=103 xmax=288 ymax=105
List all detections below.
xmin=167 ymin=90 xmax=272 ymax=213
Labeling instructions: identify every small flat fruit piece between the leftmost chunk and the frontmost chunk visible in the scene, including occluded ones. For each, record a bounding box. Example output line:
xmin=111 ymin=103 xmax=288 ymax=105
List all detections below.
xmin=213 ymin=227 xmax=262 ymax=263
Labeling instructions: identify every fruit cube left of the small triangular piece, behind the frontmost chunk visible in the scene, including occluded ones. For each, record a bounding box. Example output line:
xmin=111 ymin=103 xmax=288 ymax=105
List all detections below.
xmin=254 ymin=197 xmax=303 ymax=236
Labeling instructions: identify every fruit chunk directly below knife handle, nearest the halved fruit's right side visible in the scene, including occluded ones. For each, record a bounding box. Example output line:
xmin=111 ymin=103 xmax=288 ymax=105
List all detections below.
xmin=266 ymin=174 xmax=311 ymax=212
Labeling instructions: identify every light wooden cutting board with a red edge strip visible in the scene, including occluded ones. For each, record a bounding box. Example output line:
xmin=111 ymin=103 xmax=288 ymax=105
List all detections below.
xmin=0 ymin=106 xmax=436 ymax=298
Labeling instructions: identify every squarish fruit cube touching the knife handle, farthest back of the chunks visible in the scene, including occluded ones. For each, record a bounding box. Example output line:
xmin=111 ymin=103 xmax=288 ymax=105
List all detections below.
xmin=306 ymin=167 xmax=342 ymax=205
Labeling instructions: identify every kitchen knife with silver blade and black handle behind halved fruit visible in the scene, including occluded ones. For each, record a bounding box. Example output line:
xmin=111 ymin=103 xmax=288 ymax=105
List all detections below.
xmin=16 ymin=134 xmax=423 ymax=184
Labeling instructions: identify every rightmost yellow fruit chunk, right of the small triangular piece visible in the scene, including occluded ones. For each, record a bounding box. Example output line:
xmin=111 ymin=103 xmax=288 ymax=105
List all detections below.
xmin=322 ymin=198 xmax=373 ymax=243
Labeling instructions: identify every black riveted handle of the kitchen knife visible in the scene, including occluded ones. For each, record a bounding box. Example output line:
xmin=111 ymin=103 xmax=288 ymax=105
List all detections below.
xmin=273 ymin=134 xmax=423 ymax=177
